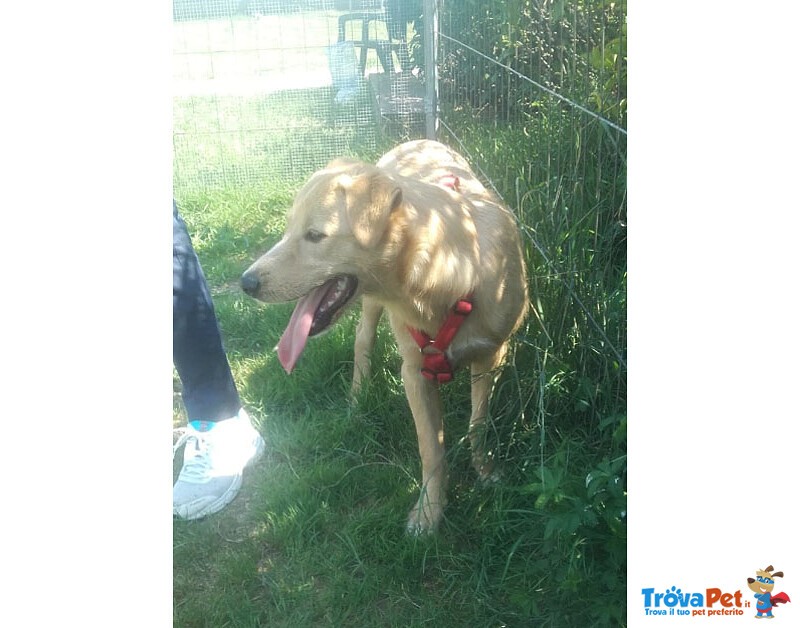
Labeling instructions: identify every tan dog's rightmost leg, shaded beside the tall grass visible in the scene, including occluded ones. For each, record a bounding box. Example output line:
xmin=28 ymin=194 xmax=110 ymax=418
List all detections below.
xmin=469 ymin=343 xmax=508 ymax=482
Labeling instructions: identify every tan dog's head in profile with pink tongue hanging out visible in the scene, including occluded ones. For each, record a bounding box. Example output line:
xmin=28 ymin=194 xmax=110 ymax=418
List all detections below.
xmin=236 ymin=159 xmax=403 ymax=371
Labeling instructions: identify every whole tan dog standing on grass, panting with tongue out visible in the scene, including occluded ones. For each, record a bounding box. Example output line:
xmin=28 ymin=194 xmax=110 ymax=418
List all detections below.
xmin=242 ymin=140 xmax=528 ymax=533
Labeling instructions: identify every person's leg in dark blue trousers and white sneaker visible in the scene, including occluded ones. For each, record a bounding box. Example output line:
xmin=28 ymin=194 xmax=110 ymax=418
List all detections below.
xmin=172 ymin=201 xmax=264 ymax=519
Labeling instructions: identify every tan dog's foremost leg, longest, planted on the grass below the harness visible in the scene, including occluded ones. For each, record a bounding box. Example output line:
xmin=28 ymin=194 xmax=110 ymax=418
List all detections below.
xmin=402 ymin=362 xmax=447 ymax=534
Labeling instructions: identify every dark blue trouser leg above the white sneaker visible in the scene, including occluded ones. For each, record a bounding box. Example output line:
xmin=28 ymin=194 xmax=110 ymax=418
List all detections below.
xmin=172 ymin=200 xmax=241 ymax=421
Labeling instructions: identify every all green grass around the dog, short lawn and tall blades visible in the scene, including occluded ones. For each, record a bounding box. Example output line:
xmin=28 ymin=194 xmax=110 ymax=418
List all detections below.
xmin=173 ymin=14 xmax=627 ymax=628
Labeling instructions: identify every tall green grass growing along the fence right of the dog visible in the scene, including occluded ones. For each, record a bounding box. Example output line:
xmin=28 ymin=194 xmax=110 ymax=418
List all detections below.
xmin=445 ymin=100 xmax=627 ymax=625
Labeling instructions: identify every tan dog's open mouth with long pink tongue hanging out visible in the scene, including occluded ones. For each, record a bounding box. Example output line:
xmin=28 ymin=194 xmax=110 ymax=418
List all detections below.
xmin=278 ymin=275 xmax=358 ymax=373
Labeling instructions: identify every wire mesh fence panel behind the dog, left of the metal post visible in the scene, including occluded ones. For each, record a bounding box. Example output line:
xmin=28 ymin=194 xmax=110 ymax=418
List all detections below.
xmin=173 ymin=0 xmax=422 ymax=196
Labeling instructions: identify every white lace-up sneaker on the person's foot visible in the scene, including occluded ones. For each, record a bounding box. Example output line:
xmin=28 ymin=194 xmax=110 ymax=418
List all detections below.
xmin=172 ymin=408 xmax=264 ymax=519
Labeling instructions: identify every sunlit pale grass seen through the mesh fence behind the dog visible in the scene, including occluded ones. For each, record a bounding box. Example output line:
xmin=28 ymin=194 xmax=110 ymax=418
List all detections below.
xmin=174 ymin=84 xmax=378 ymax=195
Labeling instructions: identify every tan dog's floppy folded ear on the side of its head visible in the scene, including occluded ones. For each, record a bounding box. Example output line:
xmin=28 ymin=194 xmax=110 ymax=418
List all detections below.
xmin=344 ymin=172 xmax=403 ymax=248
